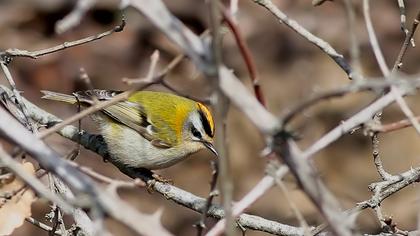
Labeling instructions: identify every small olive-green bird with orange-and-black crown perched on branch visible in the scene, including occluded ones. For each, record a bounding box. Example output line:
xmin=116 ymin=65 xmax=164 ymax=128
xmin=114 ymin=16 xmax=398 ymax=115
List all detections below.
xmin=41 ymin=89 xmax=217 ymax=170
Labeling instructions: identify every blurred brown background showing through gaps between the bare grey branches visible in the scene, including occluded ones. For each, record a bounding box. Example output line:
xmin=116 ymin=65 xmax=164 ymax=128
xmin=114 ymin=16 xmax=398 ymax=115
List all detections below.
xmin=0 ymin=0 xmax=420 ymax=235
